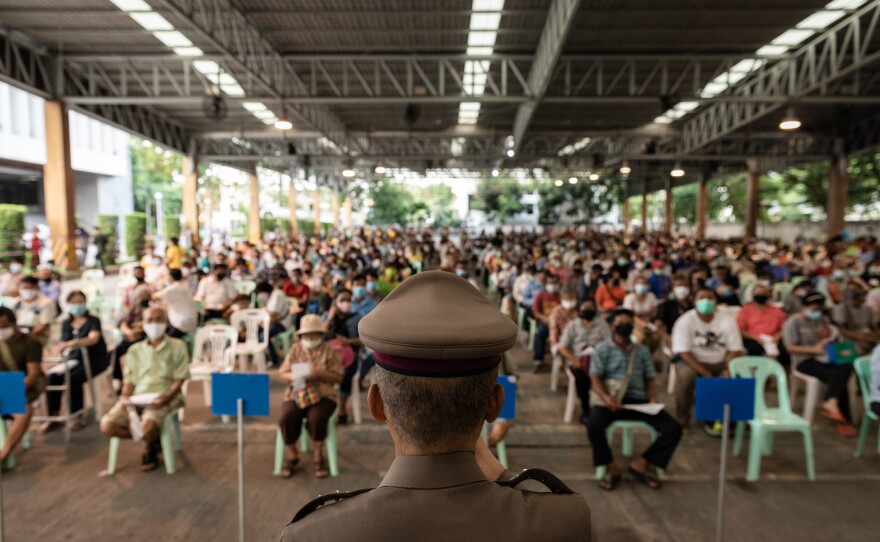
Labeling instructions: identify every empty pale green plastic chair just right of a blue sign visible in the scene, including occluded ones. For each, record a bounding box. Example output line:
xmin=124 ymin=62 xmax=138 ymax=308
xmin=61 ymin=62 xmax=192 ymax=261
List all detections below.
xmin=730 ymin=356 xmax=816 ymax=482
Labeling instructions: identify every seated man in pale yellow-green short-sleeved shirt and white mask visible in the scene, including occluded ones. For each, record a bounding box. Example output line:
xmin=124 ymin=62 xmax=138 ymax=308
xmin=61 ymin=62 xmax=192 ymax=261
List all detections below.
xmin=101 ymin=307 xmax=189 ymax=472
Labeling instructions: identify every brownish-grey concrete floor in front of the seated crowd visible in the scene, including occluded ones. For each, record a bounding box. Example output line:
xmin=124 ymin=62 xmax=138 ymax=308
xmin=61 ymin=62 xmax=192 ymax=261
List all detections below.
xmin=3 ymin=338 xmax=880 ymax=542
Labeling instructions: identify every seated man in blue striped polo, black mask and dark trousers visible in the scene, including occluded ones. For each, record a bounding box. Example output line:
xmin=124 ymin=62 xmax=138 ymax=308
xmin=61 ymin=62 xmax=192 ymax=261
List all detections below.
xmin=587 ymin=309 xmax=682 ymax=491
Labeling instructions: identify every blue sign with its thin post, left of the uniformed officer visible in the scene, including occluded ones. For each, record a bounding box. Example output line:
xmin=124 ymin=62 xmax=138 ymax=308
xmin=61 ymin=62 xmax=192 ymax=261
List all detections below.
xmin=211 ymin=373 xmax=269 ymax=542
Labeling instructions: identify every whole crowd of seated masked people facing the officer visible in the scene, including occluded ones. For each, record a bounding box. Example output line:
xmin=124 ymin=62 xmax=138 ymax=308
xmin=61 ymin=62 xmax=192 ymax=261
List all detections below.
xmin=0 ymin=229 xmax=880 ymax=489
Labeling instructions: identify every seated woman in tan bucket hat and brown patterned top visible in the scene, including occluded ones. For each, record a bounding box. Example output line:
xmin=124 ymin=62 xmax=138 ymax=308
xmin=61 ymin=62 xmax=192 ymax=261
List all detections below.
xmin=278 ymin=314 xmax=342 ymax=478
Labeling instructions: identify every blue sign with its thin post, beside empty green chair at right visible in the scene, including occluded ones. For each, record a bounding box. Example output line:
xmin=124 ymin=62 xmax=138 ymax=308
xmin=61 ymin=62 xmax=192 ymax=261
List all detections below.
xmin=694 ymin=378 xmax=755 ymax=542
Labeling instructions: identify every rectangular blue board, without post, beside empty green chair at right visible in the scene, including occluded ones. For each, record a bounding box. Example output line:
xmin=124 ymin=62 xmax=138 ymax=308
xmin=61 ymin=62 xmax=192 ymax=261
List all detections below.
xmin=694 ymin=378 xmax=755 ymax=422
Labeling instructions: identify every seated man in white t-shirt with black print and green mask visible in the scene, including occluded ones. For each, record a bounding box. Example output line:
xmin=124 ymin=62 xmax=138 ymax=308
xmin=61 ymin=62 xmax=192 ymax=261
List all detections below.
xmin=672 ymin=287 xmax=743 ymax=437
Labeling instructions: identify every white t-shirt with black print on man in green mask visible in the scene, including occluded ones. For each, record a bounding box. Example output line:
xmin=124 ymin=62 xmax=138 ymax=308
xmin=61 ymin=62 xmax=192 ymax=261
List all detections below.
xmin=672 ymin=309 xmax=744 ymax=365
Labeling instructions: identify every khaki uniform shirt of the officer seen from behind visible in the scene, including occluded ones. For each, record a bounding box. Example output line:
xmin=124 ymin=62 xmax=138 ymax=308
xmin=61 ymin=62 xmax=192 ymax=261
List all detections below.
xmin=281 ymin=452 xmax=593 ymax=542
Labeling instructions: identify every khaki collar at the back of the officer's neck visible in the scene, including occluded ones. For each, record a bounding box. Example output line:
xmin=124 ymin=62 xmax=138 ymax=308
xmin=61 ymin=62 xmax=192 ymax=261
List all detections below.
xmin=379 ymin=452 xmax=487 ymax=489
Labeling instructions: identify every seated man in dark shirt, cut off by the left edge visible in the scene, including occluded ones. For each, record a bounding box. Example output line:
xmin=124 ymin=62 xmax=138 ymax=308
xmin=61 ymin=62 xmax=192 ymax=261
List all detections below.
xmin=0 ymin=307 xmax=46 ymax=465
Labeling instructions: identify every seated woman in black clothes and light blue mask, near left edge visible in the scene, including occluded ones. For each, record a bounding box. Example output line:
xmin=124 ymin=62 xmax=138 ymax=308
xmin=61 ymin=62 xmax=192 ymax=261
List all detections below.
xmin=40 ymin=290 xmax=109 ymax=433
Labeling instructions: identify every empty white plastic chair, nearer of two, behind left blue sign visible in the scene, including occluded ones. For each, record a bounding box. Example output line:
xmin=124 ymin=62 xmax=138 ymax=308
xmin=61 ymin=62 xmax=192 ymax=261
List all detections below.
xmin=183 ymin=324 xmax=238 ymax=406
